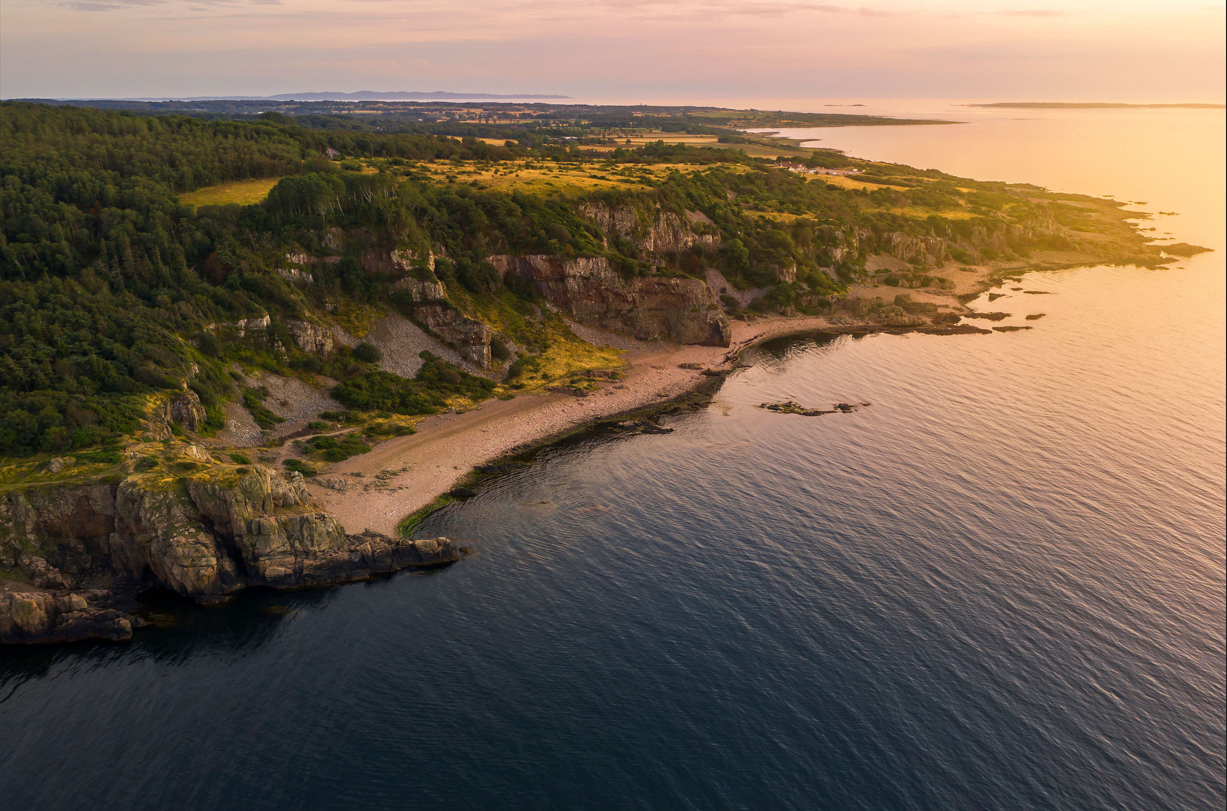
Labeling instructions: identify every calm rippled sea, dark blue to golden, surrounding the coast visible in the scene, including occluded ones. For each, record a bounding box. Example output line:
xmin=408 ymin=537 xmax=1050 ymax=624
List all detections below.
xmin=0 ymin=103 xmax=1227 ymax=810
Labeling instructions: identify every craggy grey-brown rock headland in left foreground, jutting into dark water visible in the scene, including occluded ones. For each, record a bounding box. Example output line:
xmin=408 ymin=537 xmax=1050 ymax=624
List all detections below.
xmin=0 ymin=466 xmax=459 ymax=642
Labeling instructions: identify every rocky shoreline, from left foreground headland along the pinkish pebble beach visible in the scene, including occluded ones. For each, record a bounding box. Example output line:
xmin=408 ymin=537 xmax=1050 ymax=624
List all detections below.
xmin=0 ymin=246 xmax=1163 ymax=644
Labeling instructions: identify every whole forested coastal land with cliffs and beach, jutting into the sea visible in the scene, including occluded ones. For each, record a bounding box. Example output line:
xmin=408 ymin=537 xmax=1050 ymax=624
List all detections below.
xmin=0 ymin=102 xmax=1196 ymax=643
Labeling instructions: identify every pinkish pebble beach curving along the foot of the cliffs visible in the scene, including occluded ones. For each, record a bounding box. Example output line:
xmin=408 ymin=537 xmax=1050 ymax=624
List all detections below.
xmin=307 ymin=252 xmax=1148 ymax=536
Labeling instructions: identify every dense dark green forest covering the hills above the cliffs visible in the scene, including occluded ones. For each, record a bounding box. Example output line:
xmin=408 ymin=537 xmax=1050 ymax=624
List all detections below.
xmin=0 ymin=102 xmax=1079 ymax=455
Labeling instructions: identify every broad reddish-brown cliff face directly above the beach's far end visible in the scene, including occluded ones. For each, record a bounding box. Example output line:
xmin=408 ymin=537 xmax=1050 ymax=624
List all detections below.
xmin=490 ymin=255 xmax=733 ymax=346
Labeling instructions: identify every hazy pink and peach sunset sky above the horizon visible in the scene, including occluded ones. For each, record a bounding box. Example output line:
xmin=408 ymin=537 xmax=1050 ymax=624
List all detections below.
xmin=0 ymin=0 xmax=1227 ymax=103
